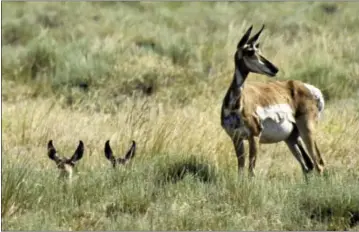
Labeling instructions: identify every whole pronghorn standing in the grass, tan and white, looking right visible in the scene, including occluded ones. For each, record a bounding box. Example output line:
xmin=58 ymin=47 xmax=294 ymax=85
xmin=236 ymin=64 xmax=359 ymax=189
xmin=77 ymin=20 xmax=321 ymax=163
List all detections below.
xmin=221 ymin=25 xmax=324 ymax=176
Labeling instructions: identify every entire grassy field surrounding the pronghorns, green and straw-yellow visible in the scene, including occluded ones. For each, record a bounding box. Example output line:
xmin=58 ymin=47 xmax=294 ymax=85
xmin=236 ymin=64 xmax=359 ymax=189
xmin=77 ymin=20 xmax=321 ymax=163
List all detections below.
xmin=1 ymin=2 xmax=359 ymax=230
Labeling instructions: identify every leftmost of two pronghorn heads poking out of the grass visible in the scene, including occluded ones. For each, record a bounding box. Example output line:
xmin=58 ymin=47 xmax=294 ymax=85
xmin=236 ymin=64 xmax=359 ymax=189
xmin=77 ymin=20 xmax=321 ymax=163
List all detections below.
xmin=47 ymin=140 xmax=84 ymax=179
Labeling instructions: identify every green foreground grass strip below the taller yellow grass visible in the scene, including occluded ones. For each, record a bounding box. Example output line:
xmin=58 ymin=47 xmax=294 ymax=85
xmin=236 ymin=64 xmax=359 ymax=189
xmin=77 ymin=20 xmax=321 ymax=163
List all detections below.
xmin=2 ymin=155 xmax=359 ymax=230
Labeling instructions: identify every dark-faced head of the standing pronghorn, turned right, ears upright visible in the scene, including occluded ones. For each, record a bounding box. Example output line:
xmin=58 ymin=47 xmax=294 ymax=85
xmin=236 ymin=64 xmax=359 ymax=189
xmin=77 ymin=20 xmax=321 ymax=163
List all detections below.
xmin=234 ymin=25 xmax=278 ymax=77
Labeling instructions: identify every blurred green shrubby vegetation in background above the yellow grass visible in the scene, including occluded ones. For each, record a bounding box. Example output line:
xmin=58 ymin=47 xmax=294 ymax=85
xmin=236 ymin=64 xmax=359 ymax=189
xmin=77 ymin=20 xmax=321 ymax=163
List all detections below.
xmin=2 ymin=2 xmax=359 ymax=108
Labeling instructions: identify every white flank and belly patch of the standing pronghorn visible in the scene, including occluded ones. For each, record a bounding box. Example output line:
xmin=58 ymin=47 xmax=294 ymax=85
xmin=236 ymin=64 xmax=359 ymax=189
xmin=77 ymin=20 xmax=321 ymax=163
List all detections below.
xmin=256 ymin=104 xmax=295 ymax=143
